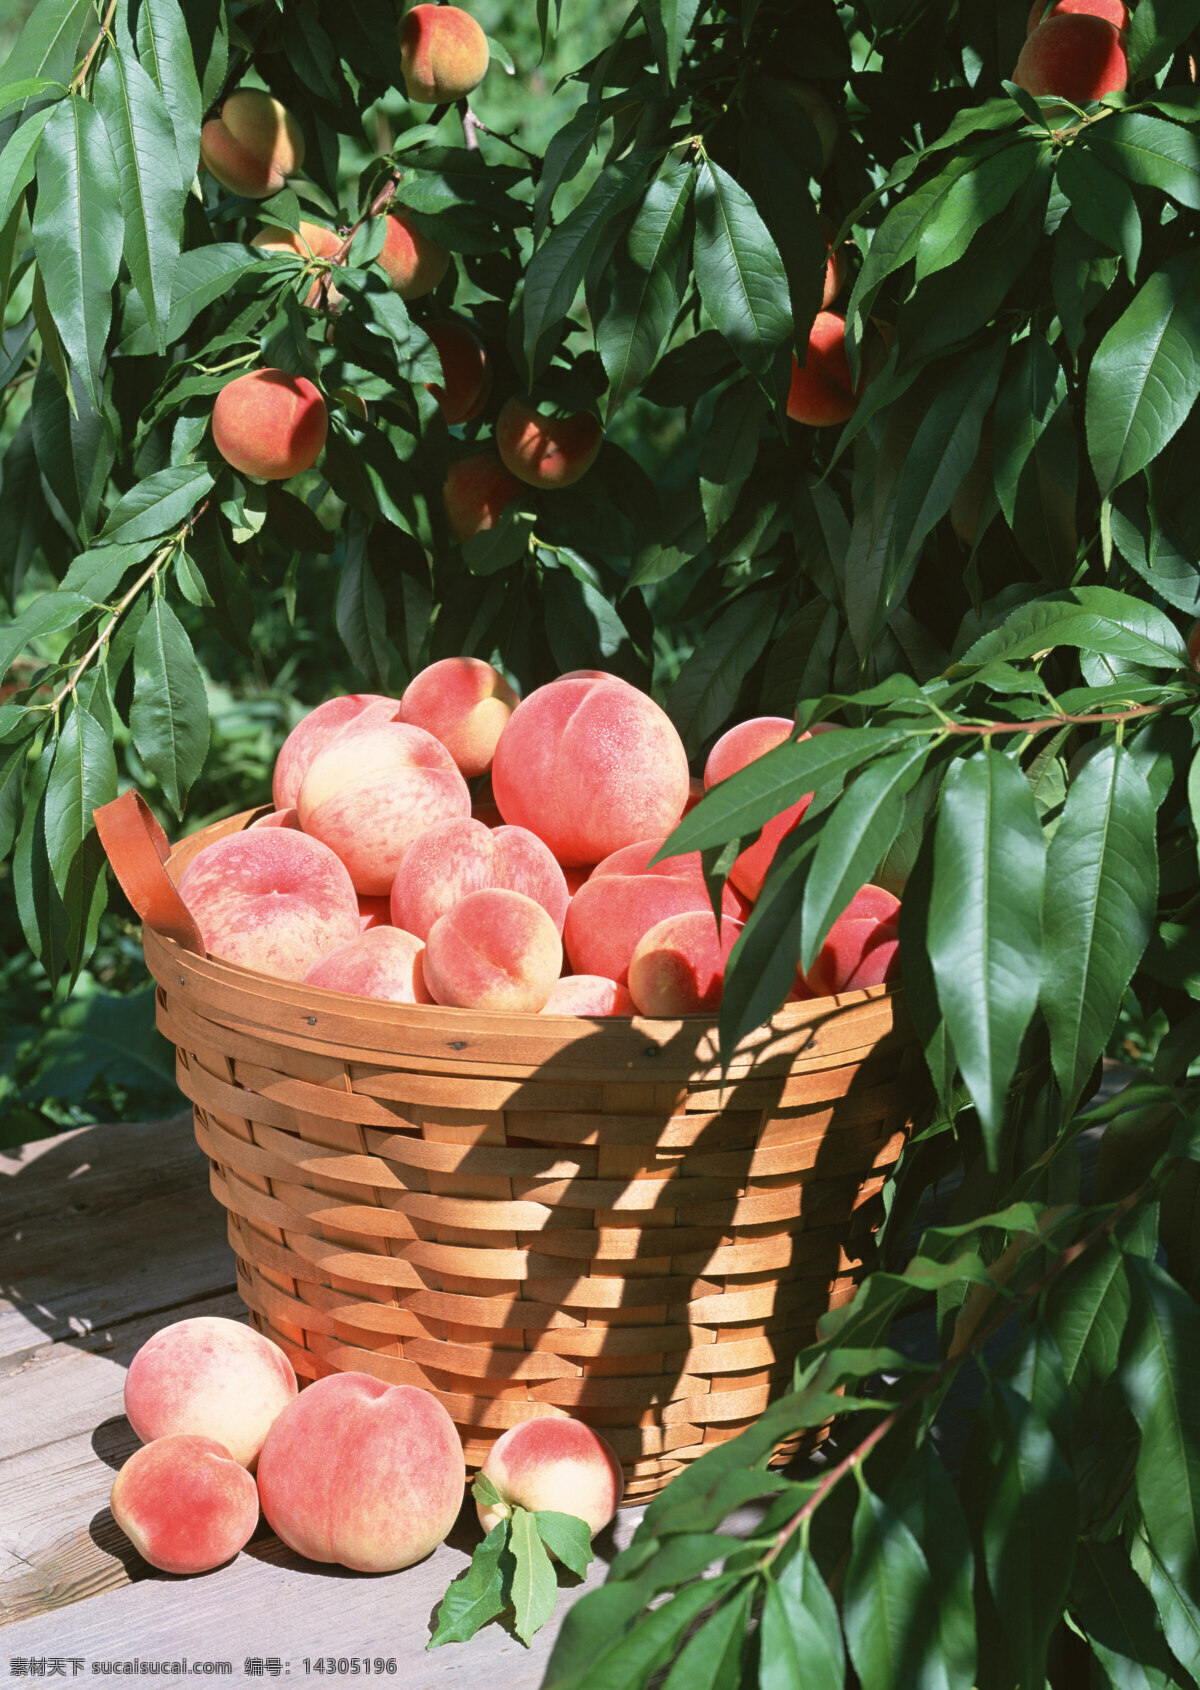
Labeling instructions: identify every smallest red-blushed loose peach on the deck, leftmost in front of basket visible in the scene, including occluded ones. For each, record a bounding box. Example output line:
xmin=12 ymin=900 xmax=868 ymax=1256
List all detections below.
xmin=110 ymin=1433 xmax=259 ymax=1573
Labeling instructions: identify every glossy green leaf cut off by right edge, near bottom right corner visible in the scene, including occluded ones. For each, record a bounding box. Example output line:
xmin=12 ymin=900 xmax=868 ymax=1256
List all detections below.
xmin=1119 ymin=1256 xmax=1200 ymax=1595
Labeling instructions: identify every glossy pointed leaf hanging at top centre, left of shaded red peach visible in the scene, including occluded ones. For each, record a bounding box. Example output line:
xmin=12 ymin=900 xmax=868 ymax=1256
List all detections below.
xmin=695 ymin=159 xmax=794 ymax=401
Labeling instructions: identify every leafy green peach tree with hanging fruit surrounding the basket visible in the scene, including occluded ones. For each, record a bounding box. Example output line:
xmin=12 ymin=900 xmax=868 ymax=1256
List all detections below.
xmin=0 ymin=0 xmax=1200 ymax=1690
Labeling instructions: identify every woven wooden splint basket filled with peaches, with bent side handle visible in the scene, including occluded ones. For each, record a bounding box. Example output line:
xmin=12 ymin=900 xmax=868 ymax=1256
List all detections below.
xmin=101 ymin=794 xmax=919 ymax=1501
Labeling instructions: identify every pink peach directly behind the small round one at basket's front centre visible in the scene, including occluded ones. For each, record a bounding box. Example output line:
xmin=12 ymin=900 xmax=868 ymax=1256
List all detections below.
xmin=392 ymin=816 xmax=570 ymax=938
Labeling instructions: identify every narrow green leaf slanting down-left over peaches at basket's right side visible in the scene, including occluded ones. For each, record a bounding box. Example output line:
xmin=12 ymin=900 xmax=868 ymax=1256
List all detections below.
xmin=799 ymin=744 xmax=930 ymax=970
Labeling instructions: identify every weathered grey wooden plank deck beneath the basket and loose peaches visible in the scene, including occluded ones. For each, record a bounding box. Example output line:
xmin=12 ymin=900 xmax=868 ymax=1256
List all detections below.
xmin=0 ymin=1115 xmax=639 ymax=1690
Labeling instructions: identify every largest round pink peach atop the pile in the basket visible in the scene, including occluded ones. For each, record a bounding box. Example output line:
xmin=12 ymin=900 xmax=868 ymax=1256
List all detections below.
xmin=492 ymin=676 xmax=688 ymax=865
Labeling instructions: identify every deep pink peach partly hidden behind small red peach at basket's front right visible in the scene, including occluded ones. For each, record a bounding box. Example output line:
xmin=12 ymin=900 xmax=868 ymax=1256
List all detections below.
xmin=563 ymin=838 xmax=749 ymax=985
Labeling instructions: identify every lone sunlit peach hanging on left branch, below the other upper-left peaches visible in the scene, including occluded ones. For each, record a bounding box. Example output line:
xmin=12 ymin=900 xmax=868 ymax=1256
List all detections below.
xmin=213 ymin=370 xmax=330 ymax=482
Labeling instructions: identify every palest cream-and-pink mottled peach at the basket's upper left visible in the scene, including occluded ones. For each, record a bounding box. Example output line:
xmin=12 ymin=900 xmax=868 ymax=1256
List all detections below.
xmin=296 ymin=722 xmax=472 ymax=899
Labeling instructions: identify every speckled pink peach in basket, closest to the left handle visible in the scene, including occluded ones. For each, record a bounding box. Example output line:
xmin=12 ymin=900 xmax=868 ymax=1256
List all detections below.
xmin=179 ymin=828 xmax=358 ymax=980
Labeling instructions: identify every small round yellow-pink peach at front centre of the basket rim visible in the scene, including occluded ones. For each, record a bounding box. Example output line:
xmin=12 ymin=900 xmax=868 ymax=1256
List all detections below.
xmin=424 ymin=887 xmax=563 ymax=1014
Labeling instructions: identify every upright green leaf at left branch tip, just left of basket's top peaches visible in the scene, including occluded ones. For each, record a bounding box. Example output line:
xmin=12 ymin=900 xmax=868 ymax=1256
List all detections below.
xmin=128 ymin=595 xmax=208 ymax=816
